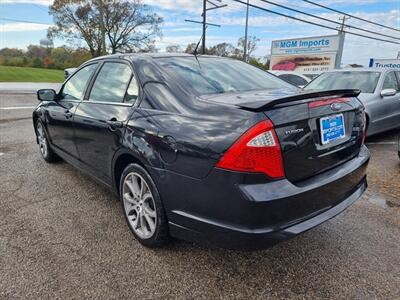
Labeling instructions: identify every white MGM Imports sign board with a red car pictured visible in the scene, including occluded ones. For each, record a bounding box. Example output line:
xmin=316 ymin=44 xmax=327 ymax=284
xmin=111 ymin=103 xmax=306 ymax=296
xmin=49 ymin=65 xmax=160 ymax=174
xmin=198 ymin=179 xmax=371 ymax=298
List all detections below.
xmin=270 ymin=35 xmax=343 ymax=74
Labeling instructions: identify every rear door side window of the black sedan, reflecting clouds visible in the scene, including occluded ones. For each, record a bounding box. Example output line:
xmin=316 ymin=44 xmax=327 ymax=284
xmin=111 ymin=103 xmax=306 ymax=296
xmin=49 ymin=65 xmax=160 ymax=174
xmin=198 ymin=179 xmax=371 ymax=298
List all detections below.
xmin=89 ymin=62 xmax=132 ymax=102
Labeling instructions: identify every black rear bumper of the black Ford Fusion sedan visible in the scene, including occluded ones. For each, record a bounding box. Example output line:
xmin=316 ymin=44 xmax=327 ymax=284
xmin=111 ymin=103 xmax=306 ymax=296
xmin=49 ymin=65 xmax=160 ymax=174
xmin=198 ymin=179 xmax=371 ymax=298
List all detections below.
xmin=161 ymin=147 xmax=369 ymax=250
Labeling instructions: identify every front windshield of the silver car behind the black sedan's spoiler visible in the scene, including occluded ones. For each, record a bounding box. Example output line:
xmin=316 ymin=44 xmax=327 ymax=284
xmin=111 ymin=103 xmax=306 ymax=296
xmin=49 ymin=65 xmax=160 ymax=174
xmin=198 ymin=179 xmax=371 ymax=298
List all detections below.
xmin=304 ymin=71 xmax=380 ymax=93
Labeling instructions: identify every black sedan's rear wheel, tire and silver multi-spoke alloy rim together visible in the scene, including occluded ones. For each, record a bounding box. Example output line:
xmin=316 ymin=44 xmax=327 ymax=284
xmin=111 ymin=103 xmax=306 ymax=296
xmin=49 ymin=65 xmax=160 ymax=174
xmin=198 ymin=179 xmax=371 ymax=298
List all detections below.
xmin=119 ymin=164 xmax=170 ymax=248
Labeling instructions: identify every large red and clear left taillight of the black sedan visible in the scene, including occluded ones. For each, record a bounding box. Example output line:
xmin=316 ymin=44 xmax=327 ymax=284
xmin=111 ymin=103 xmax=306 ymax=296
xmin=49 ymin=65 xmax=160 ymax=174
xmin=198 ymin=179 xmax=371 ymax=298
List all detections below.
xmin=217 ymin=121 xmax=285 ymax=178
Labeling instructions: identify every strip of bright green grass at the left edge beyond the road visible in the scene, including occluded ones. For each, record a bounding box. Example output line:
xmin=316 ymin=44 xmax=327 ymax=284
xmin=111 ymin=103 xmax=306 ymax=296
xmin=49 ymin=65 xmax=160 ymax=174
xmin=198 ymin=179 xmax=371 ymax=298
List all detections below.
xmin=0 ymin=66 xmax=64 ymax=82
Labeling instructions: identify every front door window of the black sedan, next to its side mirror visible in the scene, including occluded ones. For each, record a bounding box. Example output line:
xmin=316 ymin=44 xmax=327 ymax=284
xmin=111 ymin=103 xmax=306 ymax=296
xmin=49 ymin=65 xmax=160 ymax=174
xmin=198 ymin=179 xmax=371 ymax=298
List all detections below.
xmin=59 ymin=63 xmax=97 ymax=100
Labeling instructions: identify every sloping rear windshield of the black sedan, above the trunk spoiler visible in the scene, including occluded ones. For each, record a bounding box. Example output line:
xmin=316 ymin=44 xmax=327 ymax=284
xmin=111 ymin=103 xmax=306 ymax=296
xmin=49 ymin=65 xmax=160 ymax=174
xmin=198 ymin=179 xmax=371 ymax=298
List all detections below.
xmin=158 ymin=56 xmax=294 ymax=95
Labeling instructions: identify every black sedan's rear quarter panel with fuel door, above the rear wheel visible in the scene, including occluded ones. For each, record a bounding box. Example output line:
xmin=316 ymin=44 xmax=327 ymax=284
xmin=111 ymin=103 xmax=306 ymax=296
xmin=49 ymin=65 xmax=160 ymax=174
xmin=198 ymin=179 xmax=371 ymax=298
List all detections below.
xmin=125 ymin=103 xmax=257 ymax=179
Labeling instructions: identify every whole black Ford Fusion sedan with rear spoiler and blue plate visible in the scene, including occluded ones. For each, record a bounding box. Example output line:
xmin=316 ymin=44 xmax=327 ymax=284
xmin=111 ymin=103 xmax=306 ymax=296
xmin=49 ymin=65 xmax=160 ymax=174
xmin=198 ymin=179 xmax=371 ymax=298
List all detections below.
xmin=33 ymin=54 xmax=369 ymax=249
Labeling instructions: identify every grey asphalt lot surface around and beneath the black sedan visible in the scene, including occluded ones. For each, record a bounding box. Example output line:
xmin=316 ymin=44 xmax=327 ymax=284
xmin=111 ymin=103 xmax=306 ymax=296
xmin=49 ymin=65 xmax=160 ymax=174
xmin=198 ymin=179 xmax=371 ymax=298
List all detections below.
xmin=0 ymin=92 xmax=400 ymax=299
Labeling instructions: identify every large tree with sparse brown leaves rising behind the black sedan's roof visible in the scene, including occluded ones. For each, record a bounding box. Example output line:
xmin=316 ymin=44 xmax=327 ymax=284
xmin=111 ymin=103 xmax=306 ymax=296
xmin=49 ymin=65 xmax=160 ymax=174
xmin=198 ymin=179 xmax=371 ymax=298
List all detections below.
xmin=48 ymin=0 xmax=162 ymax=57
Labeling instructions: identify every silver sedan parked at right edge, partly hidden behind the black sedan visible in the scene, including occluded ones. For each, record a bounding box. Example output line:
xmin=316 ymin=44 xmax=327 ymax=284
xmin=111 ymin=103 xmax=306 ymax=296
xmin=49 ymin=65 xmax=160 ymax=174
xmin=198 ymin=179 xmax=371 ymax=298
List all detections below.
xmin=304 ymin=68 xmax=400 ymax=136
